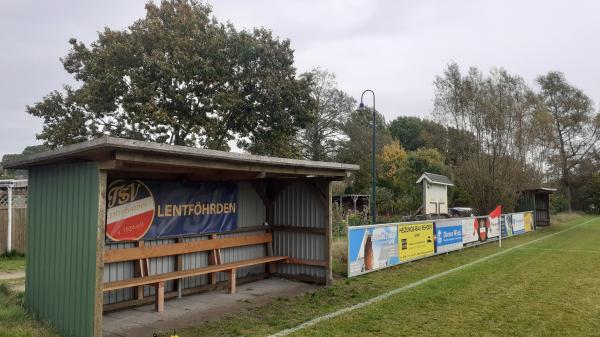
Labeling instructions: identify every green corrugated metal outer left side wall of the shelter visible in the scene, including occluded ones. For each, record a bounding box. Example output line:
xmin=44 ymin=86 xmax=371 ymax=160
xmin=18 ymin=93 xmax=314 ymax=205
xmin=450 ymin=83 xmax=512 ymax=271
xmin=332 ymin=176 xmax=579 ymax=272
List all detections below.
xmin=25 ymin=163 xmax=99 ymax=336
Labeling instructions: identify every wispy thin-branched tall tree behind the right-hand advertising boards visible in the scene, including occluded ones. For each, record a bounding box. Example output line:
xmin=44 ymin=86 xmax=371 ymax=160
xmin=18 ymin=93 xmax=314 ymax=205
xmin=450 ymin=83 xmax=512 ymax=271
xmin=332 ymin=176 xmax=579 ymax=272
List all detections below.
xmin=435 ymin=63 xmax=539 ymax=212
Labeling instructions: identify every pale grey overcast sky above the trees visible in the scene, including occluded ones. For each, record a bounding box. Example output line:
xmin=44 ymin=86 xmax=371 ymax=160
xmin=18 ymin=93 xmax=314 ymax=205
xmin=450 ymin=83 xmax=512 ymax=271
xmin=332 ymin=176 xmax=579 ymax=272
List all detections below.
xmin=0 ymin=0 xmax=600 ymax=156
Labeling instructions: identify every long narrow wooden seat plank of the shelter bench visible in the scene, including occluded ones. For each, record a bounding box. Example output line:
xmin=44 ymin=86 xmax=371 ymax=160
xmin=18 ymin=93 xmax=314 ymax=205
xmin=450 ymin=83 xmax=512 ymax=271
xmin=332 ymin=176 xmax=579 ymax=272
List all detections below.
xmin=103 ymin=256 xmax=288 ymax=291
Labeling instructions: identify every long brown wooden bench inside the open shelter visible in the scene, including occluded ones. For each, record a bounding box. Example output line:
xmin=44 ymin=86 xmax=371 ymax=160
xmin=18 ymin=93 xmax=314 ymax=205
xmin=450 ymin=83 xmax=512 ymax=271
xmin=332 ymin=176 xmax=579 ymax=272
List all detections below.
xmin=103 ymin=233 xmax=288 ymax=312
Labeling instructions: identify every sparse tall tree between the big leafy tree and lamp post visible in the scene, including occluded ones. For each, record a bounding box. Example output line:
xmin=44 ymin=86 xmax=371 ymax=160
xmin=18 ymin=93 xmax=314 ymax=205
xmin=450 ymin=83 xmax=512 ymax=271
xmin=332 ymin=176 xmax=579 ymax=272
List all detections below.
xmin=299 ymin=69 xmax=356 ymax=161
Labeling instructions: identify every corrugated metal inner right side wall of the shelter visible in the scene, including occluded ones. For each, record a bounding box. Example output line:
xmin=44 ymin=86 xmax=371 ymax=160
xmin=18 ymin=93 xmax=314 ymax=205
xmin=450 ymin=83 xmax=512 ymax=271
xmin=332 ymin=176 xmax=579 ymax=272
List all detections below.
xmin=273 ymin=181 xmax=327 ymax=278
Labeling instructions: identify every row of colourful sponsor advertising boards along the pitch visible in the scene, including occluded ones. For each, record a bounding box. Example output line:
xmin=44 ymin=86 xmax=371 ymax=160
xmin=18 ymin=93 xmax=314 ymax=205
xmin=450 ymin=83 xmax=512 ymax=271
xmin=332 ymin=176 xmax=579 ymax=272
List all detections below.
xmin=348 ymin=209 xmax=535 ymax=277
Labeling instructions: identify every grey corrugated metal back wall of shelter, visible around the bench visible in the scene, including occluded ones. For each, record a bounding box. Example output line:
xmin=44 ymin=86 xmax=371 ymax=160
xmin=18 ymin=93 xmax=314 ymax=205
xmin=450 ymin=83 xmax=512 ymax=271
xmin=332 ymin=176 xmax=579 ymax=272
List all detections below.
xmin=104 ymin=182 xmax=266 ymax=304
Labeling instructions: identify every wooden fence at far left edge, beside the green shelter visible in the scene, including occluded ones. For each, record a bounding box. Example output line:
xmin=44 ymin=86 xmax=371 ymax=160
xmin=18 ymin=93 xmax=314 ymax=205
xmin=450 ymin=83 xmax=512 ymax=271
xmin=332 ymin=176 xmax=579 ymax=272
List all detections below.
xmin=0 ymin=190 xmax=27 ymax=254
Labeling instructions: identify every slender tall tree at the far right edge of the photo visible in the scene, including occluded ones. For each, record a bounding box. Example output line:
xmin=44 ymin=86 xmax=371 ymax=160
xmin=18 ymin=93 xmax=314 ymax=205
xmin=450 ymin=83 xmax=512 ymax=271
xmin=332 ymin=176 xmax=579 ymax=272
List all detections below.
xmin=537 ymin=71 xmax=600 ymax=211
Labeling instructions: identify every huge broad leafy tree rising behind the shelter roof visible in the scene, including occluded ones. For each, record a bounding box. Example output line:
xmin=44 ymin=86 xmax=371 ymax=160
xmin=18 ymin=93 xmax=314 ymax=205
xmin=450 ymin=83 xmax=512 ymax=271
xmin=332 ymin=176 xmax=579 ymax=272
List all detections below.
xmin=27 ymin=0 xmax=312 ymax=156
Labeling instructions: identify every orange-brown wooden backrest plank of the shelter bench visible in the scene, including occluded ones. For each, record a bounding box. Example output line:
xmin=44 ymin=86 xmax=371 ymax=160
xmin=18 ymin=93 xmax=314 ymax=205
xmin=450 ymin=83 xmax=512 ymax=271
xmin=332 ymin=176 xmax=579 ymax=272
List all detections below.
xmin=104 ymin=233 xmax=273 ymax=263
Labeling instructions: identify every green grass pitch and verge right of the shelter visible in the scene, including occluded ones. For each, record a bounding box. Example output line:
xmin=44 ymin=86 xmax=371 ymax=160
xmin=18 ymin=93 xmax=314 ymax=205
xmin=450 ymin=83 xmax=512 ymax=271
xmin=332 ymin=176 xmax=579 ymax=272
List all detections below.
xmin=178 ymin=216 xmax=600 ymax=337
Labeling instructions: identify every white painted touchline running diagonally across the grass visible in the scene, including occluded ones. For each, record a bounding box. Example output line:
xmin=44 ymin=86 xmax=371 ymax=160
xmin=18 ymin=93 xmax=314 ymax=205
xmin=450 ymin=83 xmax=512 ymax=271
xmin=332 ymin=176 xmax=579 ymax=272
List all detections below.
xmin=269 ymin=218 xmax=598 ymax=337
